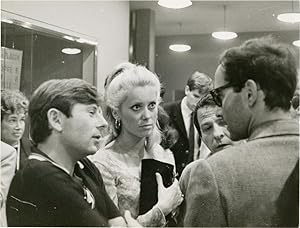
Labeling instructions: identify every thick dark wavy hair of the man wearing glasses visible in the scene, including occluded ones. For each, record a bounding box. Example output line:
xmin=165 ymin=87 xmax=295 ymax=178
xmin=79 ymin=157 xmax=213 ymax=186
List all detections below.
xmin=220 ymin=36 xmax=297 ymax=110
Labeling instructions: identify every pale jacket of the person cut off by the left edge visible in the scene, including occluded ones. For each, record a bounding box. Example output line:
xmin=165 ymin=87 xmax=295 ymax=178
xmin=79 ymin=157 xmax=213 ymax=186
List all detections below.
xmin=0 ymin=141 xmax=17 ymax=227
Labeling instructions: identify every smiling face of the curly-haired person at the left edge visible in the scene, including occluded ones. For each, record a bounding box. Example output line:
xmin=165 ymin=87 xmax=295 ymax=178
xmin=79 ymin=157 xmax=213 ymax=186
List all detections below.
xmin=1 ymin=111 xmax=26 ymax=146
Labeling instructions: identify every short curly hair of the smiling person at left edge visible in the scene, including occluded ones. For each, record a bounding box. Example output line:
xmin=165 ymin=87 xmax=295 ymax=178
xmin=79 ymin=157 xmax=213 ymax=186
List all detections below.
xmin=1 ymin=89 xmax=28 ymax=121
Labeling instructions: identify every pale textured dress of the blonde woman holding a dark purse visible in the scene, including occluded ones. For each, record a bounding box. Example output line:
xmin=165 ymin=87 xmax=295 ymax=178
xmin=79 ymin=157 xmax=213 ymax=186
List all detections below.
xmin=89 ymin=142 xmax=175 ymax=227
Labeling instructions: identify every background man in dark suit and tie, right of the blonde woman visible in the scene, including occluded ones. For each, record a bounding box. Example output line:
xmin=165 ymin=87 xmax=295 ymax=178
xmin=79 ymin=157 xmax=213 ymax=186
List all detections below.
xmin=163 ymin=71 xmax=212 ymax=178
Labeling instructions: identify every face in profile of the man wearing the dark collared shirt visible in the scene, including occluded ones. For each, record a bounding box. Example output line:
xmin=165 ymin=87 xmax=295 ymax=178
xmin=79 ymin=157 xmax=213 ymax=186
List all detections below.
xmin=61 ymin=103 xmax=107 ymax=159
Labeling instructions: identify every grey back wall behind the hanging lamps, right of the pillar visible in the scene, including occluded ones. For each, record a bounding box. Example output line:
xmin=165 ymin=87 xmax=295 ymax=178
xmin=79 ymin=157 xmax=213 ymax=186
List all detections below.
xmin=155 ymin=31 xmax=299 ymax=102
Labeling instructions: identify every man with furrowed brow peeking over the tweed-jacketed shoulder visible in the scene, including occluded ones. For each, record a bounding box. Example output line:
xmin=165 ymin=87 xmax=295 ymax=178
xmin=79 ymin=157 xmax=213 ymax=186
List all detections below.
xmin=194 ymin=94 xmax=233 ymax=159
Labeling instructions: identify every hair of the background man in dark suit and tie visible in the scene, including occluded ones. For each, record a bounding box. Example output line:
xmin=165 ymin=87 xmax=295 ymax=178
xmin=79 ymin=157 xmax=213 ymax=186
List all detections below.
xmin=186 ymin=71 xmax=213 ymax=93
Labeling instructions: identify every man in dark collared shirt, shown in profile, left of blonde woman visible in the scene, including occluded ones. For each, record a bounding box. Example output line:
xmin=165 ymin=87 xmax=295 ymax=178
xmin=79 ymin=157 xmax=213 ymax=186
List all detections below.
xmin=7 ymin=79 xmax=134 ymax=226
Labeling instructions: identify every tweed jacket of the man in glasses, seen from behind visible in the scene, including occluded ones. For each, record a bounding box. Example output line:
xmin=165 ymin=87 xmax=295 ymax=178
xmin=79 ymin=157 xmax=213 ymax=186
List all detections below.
xmin=180 ymin=120 xmax=299 ymax=227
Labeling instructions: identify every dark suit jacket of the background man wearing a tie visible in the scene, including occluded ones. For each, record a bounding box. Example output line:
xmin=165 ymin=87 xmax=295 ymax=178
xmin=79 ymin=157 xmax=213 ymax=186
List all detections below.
xmin=163 ymin=100 xmax=193 ymax=177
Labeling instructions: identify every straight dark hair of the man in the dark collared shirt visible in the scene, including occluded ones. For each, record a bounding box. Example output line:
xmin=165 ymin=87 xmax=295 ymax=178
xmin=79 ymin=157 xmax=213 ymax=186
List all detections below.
xmin=29 ymin=78 xmax=100 ymax=144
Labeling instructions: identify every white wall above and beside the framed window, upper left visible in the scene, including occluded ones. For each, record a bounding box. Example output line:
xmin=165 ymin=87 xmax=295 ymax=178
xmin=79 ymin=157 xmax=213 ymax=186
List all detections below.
xmin=1 ymin=0 xmax=129 ymax=91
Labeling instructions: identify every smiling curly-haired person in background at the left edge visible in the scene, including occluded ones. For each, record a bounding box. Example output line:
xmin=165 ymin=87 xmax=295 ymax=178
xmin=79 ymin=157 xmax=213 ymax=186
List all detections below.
xmin=1 ymin=89 xmax=31 ymax=170
